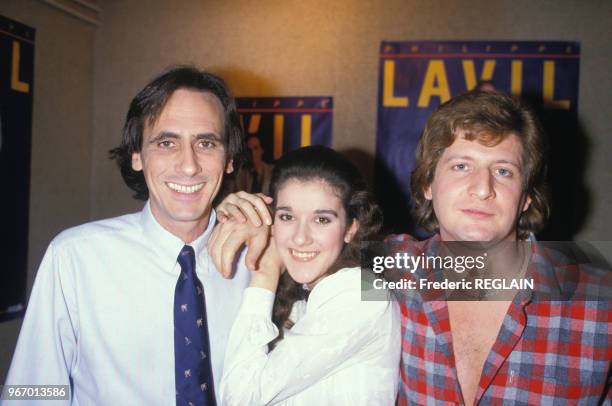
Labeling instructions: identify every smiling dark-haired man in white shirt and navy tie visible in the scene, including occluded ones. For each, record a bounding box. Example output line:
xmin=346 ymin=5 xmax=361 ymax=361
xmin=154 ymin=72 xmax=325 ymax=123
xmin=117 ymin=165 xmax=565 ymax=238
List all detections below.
xmin=6 ymin=67 xmax=248 ymax=405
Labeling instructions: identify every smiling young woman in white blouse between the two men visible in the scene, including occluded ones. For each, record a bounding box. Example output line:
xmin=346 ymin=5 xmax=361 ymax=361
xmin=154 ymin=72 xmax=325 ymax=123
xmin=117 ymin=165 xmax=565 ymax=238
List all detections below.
xmin=220 ymin=147 xmax=400 ymax=406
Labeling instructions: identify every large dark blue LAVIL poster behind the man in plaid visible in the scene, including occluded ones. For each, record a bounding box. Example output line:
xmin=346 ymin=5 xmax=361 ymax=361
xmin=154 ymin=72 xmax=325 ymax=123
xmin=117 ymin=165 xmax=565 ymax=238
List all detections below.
xmin=376 ymin=41 xmax=584 ymax=236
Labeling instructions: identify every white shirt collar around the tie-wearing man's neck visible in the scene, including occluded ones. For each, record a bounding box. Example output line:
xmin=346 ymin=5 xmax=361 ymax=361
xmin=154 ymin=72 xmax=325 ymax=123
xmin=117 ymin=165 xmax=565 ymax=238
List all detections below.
xmin=141 ymin=201 xmax=217 ymax=272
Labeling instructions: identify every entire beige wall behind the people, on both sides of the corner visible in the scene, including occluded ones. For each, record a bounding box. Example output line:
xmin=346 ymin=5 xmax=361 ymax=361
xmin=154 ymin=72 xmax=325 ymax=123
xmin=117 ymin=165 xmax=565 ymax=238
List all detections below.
xmin=0 ymin=0 xmax=612 ymax=380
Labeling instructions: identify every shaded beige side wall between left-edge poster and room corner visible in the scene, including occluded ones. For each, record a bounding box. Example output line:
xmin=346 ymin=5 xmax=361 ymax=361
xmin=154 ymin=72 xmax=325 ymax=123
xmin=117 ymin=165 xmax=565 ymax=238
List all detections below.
xmin=0 ymin=0 xmax=95 ymax=383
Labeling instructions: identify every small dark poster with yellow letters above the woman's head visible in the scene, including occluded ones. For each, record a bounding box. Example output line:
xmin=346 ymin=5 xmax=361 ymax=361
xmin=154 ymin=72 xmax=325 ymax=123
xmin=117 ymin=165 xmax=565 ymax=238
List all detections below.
xmin=236 ymin=97 xmax=334 ymax=163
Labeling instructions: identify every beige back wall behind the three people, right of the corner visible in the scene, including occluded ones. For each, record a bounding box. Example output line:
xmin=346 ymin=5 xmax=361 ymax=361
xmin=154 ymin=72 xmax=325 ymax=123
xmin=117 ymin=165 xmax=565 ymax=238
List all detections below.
xmin=91 ymin=0 xmax=612 ymax=244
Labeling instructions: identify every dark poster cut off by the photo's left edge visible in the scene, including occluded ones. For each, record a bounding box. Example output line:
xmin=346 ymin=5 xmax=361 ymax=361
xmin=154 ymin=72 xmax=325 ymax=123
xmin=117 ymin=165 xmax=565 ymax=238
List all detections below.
xmin=0 ymin=16 xmax=35 ymax=321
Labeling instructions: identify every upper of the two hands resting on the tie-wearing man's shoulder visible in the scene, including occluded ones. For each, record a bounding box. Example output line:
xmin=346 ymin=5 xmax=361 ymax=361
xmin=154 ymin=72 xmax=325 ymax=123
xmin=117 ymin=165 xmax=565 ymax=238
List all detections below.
xmin=215 ymin=191 xmax=272 ymax=227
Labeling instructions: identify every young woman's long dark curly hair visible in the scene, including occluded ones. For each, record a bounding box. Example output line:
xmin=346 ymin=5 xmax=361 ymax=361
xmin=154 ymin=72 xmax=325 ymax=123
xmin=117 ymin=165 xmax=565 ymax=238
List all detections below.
xmin=270 ymin=146 xmax=382 ymax=349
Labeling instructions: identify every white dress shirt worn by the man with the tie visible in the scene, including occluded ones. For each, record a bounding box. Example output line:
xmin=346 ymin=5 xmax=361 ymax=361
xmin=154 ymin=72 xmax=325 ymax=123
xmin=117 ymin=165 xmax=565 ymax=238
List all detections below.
xmin=6 ymin=203 xmax=249 ymax=406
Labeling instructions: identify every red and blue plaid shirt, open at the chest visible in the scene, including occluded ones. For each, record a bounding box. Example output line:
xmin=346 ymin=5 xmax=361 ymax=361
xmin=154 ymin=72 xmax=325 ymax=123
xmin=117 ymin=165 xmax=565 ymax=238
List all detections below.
xmin=388 ymin=235 xmax=612 ymax=406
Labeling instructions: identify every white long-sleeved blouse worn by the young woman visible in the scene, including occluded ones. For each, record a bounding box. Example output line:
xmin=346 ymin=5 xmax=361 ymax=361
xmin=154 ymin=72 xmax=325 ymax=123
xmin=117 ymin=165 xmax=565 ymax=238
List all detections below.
xmin=220 ymin=268 xmax=401 ymax=406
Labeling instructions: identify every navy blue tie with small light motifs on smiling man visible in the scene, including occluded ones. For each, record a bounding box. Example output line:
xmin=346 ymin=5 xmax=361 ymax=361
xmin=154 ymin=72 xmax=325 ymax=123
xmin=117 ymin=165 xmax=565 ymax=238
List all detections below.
xmin=174 ymin=245 xmax=216 ymax=406
